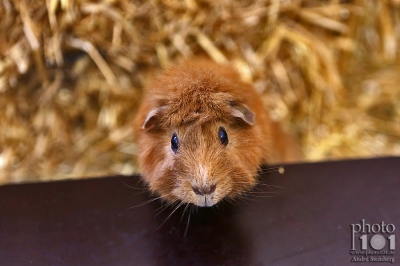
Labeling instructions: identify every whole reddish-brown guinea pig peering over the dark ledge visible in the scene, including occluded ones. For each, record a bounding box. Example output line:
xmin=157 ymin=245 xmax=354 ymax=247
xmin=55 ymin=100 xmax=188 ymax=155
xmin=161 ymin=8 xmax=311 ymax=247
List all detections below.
xmin=134 ymin=59 xmax=298 ymax=206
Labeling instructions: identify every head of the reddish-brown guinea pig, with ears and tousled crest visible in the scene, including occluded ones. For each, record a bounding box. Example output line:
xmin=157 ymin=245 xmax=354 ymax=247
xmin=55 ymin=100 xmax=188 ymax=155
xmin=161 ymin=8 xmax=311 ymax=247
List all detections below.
xmin=138 ymin=68 xmax=262 ymax=206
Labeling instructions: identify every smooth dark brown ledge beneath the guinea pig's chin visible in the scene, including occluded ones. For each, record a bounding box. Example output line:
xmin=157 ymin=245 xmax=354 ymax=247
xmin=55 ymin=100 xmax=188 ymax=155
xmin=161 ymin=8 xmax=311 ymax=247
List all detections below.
xmin=0 ymin=158 xmax=400 ymax=265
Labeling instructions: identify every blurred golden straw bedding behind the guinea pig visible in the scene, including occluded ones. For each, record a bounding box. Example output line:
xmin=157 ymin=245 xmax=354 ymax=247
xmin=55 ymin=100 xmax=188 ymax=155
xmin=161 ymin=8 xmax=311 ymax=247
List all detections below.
xmin=0 ymin=0 xmax=400 ymax=183
